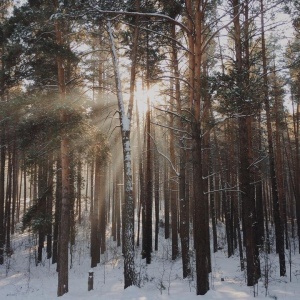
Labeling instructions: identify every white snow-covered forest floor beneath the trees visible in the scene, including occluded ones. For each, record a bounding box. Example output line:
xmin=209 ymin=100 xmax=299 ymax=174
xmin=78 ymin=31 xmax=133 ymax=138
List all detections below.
xmin=0 ymin=211 xmax=300 ymax=300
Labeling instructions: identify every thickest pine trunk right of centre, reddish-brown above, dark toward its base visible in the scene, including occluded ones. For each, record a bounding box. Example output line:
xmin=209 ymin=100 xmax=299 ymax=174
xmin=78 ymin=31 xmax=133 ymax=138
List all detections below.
xmin=186 ymin=0 xmax=210 ymax=295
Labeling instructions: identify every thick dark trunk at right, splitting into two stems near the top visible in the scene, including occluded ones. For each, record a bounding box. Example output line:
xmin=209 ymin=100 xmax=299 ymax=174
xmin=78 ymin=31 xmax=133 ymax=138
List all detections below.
xmin=232 ymin=0 xmax=260 ymax=286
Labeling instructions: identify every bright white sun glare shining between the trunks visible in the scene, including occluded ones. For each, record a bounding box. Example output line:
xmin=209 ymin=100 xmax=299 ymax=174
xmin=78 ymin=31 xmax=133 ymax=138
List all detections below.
xmin=135 ymin=82 xmax=165 ymax=115
